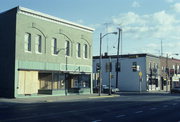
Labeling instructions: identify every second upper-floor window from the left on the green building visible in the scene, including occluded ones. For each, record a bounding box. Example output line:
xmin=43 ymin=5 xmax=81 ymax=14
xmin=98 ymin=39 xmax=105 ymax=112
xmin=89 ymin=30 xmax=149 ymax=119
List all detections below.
xmin=35 ymin=35 xmax=42 ymax=53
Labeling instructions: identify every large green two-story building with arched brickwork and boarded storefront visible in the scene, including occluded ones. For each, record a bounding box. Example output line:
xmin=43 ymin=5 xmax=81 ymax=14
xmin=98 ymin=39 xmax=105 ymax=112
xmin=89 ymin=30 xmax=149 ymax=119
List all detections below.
xmin=0 ymin=7 xmax=94 ymax=97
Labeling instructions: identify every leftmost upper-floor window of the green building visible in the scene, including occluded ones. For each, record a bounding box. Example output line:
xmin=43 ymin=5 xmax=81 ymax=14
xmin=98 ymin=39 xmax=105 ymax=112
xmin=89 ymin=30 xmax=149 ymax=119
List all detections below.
xmin=24 ymin=33 xmax=31 ymax=52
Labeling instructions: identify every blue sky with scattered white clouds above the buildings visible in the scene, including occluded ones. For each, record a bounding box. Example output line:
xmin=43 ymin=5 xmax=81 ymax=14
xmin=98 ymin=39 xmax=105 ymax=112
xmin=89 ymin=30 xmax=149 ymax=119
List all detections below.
xmin=0 ymin=0 xmax=180 ymax=58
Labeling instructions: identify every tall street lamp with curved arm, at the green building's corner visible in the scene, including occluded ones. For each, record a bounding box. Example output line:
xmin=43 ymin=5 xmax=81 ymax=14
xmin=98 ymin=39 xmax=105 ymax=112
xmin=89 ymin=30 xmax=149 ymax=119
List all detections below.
xmin=99 ymin=32 xmax=117 ymax=96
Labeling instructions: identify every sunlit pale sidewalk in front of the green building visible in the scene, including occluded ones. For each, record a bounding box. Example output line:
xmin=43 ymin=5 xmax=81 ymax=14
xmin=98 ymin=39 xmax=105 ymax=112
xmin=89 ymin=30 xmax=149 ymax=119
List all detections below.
xmin=0 ymin=94 xmax=120 ymax=103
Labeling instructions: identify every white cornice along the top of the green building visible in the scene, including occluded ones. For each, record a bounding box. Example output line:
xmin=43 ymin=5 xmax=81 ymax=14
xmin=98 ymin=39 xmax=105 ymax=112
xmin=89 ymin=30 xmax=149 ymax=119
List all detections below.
xmin=2 ymin=6 xmax=95 ymax=32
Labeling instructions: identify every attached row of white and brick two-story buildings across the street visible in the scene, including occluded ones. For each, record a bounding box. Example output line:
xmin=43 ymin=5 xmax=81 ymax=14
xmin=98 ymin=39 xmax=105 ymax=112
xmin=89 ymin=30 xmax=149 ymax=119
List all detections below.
xmin=93 ymin=53 xmax=180 ymax=91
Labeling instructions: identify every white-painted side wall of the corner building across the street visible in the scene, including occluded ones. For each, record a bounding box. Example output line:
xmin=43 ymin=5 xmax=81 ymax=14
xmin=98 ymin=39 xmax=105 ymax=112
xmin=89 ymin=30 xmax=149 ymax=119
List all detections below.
xmin=93 ymin=53 xmax=159 ymax=91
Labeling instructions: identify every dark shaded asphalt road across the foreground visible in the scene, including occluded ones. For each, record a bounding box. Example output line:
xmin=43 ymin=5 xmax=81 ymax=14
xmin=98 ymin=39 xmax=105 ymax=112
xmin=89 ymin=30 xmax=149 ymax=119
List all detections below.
xmin=0 ymin=94 xmax=180 ymax=122
